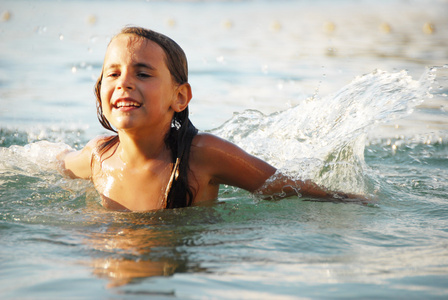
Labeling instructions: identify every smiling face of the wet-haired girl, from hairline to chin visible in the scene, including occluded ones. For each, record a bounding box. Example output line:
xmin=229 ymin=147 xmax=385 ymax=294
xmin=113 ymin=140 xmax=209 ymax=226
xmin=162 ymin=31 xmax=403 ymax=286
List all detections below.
xmin=100 ymin=34 xmax=177 ymax=134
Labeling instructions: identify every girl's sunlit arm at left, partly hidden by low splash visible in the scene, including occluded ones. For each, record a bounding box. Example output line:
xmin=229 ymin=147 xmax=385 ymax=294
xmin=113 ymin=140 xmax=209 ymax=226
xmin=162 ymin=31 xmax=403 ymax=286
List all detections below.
xmin=57 ymin=138 xmax=100 ymax=179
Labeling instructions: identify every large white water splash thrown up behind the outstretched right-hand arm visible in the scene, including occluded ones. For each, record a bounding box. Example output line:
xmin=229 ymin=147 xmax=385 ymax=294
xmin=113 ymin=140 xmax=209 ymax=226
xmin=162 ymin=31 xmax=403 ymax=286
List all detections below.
xmin=213 ymin=68 xmax=437 ymax=193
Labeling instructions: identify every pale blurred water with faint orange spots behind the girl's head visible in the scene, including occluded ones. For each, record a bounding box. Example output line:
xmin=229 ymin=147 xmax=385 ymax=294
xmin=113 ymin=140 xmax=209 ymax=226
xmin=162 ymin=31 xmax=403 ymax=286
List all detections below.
xmin=0 ymin=0 xmax=448 ymax=137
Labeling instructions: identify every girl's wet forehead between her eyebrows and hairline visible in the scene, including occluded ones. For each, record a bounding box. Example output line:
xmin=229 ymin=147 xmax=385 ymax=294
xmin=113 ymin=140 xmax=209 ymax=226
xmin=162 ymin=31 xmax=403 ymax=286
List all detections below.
xmin=104 ymin=34 xmax=165 ymax=66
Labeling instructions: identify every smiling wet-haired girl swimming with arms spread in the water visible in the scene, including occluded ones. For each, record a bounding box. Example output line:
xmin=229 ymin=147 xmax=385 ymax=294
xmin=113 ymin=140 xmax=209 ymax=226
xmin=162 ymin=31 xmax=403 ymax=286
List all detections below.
xmin=60 ymin=27 xmax=362 ymax=211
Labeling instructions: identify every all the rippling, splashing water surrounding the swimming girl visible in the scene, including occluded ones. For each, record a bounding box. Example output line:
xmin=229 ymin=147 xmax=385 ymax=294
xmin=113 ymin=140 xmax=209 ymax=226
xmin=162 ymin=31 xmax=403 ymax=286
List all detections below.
xmin=0 ymin=0 xmax=448 ymax=299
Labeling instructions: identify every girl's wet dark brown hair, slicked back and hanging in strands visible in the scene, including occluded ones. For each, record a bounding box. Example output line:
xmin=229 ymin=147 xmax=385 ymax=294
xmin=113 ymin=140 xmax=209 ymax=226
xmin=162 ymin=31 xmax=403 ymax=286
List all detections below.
xmin=95 ymin=27 xmax=198 ymax=208
